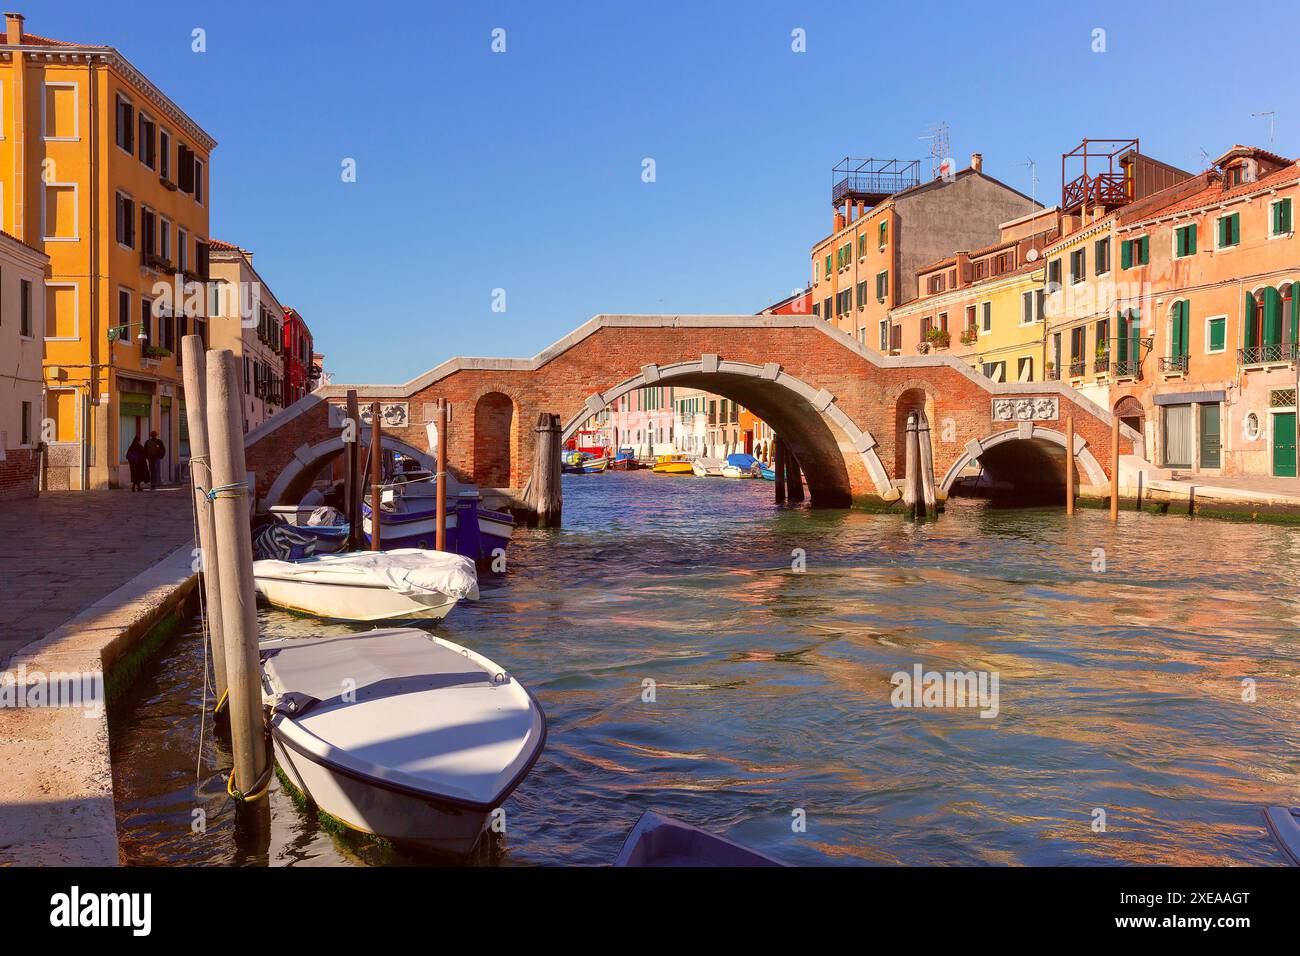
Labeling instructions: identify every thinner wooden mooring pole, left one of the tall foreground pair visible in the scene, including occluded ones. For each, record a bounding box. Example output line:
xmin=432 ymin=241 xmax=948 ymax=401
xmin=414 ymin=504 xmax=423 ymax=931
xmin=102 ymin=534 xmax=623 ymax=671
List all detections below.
xmin=181 ymin=336 xmax=230 ymax=706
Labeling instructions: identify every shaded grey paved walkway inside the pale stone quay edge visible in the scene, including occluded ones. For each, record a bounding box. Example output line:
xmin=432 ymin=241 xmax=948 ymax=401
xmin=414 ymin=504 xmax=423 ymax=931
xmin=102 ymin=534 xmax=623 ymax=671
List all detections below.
xmin=0 ymin=486 xmax=194 ymax=669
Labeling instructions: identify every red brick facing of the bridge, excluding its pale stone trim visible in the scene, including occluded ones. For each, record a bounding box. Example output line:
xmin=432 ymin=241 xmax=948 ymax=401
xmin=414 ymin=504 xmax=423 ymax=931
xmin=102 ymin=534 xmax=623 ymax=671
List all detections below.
xmin=247 ymin=326 xmax=1131 ymax=496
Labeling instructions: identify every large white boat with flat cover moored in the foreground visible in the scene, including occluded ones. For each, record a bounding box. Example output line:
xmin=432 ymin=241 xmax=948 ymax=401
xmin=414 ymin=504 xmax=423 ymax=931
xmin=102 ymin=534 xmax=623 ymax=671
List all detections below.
xmin=261 ymin=628 xmax=546 ymax=856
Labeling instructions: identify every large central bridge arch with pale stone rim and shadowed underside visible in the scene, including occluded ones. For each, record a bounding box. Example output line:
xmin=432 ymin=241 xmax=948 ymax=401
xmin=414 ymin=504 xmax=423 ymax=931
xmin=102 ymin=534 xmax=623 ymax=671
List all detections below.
xmin=560 ymin=355 xmax=893 ymax=507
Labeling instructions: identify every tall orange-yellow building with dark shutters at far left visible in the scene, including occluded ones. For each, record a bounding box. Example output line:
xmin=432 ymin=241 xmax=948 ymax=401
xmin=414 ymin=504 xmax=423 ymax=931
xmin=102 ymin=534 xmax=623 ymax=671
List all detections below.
xmin=0 ymin=13 xmax=216 ymax=488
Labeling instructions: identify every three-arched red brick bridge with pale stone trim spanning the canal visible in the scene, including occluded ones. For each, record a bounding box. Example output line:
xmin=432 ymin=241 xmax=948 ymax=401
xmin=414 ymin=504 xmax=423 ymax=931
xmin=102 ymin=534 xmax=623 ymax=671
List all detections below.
xmin=246 ymin=315 xmax=1140 ymax=507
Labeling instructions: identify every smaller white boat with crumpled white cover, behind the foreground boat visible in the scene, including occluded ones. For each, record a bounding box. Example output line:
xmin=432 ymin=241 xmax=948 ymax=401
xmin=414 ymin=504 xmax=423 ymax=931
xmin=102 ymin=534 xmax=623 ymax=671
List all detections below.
xmin=252 ymin=548 xmax=478 ymax=620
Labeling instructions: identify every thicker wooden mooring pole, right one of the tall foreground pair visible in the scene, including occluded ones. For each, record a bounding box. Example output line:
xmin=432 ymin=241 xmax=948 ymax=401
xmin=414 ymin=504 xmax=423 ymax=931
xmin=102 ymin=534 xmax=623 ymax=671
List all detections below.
xmin=207 ymin=349 xmax=267 ymax=793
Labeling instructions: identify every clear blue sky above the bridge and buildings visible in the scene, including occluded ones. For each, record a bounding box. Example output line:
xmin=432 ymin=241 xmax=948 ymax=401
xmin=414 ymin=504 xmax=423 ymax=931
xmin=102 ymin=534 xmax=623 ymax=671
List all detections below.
xmin=35 ymin=0 xmax=1300 ymax=382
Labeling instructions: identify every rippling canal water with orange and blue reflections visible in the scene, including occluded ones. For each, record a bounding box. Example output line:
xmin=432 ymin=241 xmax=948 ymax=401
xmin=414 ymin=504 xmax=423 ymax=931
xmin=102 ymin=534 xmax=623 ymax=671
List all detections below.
xmin=112 ymin=472 xmax=1300 ymax=866
